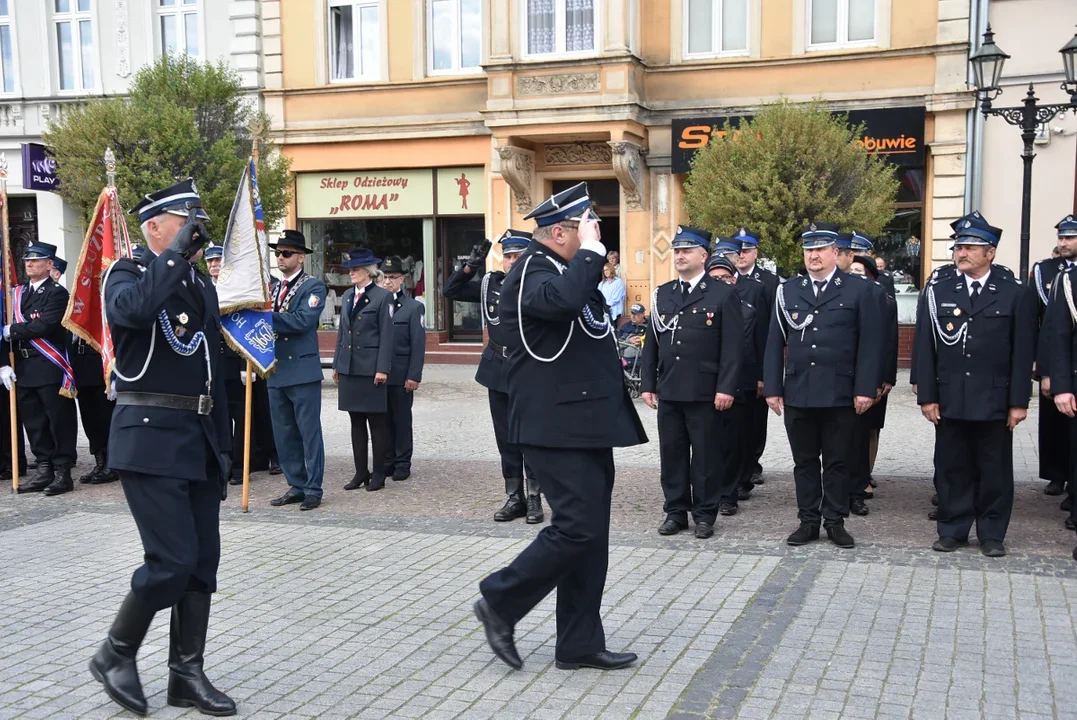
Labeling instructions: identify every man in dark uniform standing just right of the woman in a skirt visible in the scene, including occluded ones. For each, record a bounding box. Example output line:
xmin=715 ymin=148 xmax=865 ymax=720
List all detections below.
xmin=381 ymin=256 xmax=426 ymax=480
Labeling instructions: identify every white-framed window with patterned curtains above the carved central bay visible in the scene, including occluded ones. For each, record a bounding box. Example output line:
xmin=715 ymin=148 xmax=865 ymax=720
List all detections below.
xmin=523 ymin=0 xmax=601 ymax=55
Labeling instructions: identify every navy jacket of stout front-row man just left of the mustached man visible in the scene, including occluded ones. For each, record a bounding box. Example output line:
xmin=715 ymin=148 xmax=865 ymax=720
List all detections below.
xmin=764 ymin=270 xmax=882 ymax=408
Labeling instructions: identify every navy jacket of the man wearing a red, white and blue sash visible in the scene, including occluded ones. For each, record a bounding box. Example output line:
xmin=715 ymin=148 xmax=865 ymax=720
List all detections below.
xmin=11 ymin=279 xmax=68 ymax=387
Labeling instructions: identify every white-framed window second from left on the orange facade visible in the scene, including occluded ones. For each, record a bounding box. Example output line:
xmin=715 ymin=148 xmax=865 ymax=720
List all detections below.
xmin=426 ymin=0 xmax=482 ymax=74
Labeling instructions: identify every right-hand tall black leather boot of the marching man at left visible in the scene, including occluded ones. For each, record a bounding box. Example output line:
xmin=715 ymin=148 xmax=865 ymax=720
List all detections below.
xmin=168 ymin=592 xmax=236 ymax=717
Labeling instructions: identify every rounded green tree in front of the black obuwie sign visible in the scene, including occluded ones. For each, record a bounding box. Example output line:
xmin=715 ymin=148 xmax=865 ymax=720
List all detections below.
xmin=685 ymin=100 xmax=898 ymax=272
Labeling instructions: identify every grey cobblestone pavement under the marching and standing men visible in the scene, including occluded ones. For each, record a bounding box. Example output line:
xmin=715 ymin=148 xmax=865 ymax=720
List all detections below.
xmin=0 ymin=366 xmax=1077 ymax=719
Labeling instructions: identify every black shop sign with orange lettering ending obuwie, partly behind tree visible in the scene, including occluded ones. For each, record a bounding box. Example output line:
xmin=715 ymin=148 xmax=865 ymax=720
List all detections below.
xmin=670 ymin=108 xmax=926 ymax=174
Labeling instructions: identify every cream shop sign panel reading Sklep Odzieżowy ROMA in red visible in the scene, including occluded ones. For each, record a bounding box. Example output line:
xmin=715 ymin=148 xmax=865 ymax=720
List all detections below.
xmin=295 ymin=170 xmax=434 ymax=218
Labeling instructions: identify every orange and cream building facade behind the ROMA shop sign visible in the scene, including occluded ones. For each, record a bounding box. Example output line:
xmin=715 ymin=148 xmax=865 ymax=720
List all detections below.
xmin=262 ymin=0 xmax=973 ymax=352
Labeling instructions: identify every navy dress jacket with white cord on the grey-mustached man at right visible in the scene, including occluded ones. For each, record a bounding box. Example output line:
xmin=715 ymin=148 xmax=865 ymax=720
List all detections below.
xmin=915 ymin=272 xmax=1036 ymax=421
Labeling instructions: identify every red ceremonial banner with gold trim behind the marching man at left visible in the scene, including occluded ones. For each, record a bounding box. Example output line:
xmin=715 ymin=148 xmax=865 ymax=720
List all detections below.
xmin=64 ymin=186 xmax=130 ymax=393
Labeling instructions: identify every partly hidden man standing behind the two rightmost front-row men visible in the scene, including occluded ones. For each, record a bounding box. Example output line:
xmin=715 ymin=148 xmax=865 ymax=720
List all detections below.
xmin=1025 ymin=215 xmax=1077 ymax=499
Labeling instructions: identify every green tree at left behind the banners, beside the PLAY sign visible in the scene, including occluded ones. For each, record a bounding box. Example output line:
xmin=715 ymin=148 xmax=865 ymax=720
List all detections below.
xmin=44 ymin=55 xmax=290 ymax=242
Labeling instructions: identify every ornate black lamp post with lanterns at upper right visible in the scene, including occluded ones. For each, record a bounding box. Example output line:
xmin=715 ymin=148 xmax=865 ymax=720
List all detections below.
xmin=968 ymin=25 xmax=1077 ymax=282
